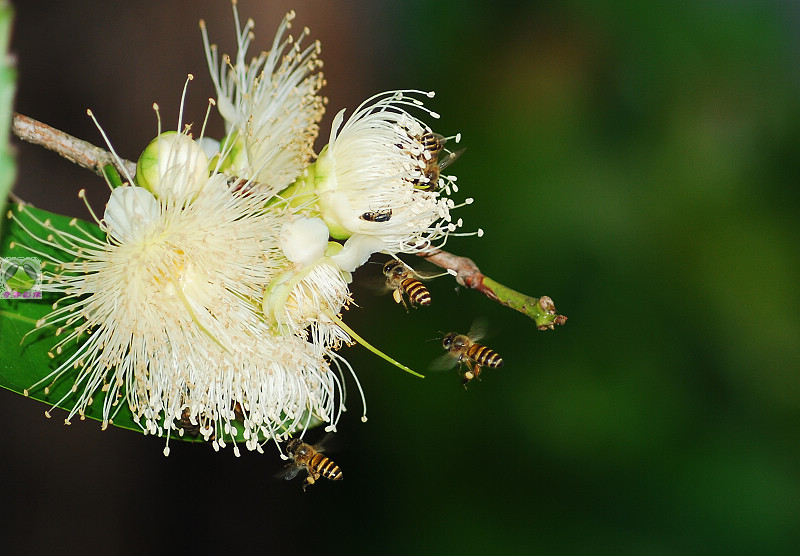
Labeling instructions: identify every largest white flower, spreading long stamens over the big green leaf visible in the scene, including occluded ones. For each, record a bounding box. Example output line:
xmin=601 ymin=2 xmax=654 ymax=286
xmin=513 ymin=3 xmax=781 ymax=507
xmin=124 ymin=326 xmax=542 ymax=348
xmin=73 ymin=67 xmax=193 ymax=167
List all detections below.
xmin=14 ymin=162 xmax=349 ymax=453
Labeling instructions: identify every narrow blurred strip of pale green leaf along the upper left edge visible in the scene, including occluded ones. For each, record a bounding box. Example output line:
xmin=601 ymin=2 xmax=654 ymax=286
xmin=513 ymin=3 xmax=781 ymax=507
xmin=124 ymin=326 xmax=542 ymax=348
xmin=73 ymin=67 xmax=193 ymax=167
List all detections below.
xmin=0 ymin=1 xmax=17 ymax=215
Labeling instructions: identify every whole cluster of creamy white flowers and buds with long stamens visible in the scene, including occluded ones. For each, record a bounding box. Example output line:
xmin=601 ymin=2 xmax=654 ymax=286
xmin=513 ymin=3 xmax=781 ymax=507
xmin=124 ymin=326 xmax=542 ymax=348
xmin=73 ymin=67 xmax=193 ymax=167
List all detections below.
xmin=14 ymin=4 xmax=468 ymax=453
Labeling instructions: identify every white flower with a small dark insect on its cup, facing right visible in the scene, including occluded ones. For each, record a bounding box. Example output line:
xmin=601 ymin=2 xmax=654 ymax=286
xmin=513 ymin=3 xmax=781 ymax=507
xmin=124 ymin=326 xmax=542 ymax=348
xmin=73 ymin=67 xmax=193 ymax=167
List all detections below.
xmin=290 ymin=91 xmax=456 ymax=256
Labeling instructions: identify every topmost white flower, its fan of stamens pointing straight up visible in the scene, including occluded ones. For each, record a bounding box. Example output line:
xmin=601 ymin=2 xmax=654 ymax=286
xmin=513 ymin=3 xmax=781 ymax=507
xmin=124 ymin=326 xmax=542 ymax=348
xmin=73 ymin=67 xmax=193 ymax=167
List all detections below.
xmin=200 ymin=3 xmax=325 ymax=191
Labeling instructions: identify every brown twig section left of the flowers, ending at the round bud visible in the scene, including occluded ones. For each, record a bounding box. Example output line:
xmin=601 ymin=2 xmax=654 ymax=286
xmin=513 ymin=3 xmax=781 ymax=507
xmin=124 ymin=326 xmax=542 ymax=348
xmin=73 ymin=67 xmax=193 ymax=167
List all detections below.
xmin=11 ymin=113 xmax=136 ymax=177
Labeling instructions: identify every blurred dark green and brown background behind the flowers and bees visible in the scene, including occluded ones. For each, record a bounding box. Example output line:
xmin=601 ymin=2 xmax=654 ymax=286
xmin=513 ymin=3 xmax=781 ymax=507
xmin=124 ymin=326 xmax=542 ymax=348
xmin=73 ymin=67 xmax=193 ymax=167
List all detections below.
xmin=0 ymin=0 xmax=800 ymax=556
